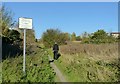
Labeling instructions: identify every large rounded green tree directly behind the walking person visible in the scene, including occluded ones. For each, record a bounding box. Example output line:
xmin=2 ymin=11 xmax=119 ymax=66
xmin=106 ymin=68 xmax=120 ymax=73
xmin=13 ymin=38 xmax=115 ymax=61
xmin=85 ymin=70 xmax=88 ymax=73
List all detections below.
xmin=42 ymin=29 xmax=66 ymax=48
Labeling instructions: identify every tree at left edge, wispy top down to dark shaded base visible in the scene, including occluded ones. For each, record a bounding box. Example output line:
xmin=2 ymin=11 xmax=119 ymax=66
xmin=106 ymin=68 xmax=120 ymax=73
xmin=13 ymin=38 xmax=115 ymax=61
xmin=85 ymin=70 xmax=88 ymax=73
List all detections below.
xmin=0 ymin=6 xmax=22 ymax=59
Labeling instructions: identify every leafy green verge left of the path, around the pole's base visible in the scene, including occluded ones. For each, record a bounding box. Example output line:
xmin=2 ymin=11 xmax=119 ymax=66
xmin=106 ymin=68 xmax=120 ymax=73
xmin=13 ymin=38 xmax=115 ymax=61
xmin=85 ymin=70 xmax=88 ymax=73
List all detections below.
xmin=2 ymin=49 xmax=55 ymax=83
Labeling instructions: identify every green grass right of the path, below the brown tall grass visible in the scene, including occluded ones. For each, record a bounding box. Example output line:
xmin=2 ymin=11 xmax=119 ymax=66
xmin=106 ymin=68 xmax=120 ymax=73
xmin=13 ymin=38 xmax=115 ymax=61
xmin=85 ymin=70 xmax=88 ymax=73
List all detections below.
xmin=55 ymin=54 xmax=118 ymax=82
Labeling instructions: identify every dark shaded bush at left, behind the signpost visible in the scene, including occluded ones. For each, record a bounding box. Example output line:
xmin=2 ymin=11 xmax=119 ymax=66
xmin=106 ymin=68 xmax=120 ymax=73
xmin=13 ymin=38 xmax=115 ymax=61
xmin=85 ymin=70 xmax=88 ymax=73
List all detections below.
xmin=2 ymin=30 xmax=22 ymax=59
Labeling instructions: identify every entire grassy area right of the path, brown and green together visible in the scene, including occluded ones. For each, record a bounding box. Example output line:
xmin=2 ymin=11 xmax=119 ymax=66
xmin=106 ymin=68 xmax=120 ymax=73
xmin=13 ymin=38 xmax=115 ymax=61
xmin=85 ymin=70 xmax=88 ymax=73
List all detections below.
xmin=48 ymin=44 xmax=120 ymax=82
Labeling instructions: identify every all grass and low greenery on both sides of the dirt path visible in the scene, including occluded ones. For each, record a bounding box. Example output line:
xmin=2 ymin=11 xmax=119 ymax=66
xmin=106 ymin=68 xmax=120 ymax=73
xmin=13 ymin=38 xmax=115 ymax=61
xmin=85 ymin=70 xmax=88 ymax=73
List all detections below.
xmin=2 ymin=42 xmax=120 ymax=82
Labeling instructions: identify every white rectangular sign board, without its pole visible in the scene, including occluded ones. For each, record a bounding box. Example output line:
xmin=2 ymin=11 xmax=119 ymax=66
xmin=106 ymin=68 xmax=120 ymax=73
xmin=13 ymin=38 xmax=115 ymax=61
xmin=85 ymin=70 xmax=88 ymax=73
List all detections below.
xmin=19 ymin=18 xmax=32 ymax=29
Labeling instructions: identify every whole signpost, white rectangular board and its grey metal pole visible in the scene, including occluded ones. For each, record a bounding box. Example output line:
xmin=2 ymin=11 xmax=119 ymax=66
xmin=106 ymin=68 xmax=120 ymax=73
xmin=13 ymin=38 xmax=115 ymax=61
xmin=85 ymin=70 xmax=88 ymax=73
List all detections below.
xmin=19 ymin=18 xmax=32 ymax=73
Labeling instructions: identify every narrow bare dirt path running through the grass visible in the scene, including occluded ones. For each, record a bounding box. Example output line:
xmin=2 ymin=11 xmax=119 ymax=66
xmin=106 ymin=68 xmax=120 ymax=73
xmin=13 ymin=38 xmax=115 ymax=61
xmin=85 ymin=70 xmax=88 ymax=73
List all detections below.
xmin=48 ymin=56 xmax=67 ymax=82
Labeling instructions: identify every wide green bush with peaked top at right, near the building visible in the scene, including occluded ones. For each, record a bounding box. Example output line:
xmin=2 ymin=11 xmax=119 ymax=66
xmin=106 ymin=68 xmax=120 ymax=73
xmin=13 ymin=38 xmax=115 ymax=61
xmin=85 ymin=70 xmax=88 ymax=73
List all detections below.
xmin=82 ymin=29 xmax=118 ymax=44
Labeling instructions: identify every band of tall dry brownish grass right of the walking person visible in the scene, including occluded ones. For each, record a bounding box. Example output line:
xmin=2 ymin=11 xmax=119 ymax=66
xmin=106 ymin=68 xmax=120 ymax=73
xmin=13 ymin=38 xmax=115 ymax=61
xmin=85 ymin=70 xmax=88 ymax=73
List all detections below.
xmin=60 ymin=43 xmax=118 ymax=61
